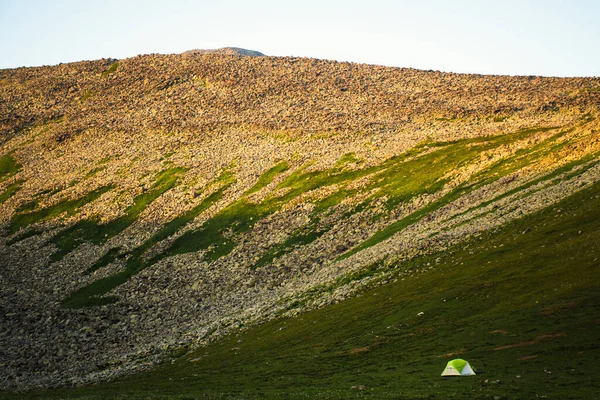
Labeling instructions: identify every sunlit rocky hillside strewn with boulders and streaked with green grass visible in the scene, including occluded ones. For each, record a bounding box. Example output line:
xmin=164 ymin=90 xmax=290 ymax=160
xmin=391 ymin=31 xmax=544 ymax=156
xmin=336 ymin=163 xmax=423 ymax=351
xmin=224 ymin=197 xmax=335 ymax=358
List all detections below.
xmin=0 ymin=52 xmax=600 ymax=389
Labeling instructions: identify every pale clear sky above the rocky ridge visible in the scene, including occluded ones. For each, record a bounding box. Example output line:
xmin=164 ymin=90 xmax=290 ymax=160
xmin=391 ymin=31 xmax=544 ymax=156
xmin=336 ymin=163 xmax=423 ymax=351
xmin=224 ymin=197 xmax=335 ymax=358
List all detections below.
xmin=0 ymin=0 xmax=600 ymax=76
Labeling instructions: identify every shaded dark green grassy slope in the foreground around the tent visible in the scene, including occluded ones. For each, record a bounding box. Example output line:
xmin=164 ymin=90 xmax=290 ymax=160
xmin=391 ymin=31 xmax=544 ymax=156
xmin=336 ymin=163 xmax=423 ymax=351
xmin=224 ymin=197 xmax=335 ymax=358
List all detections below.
xmin=9 ymin=162 xmax=600 ymax=399
